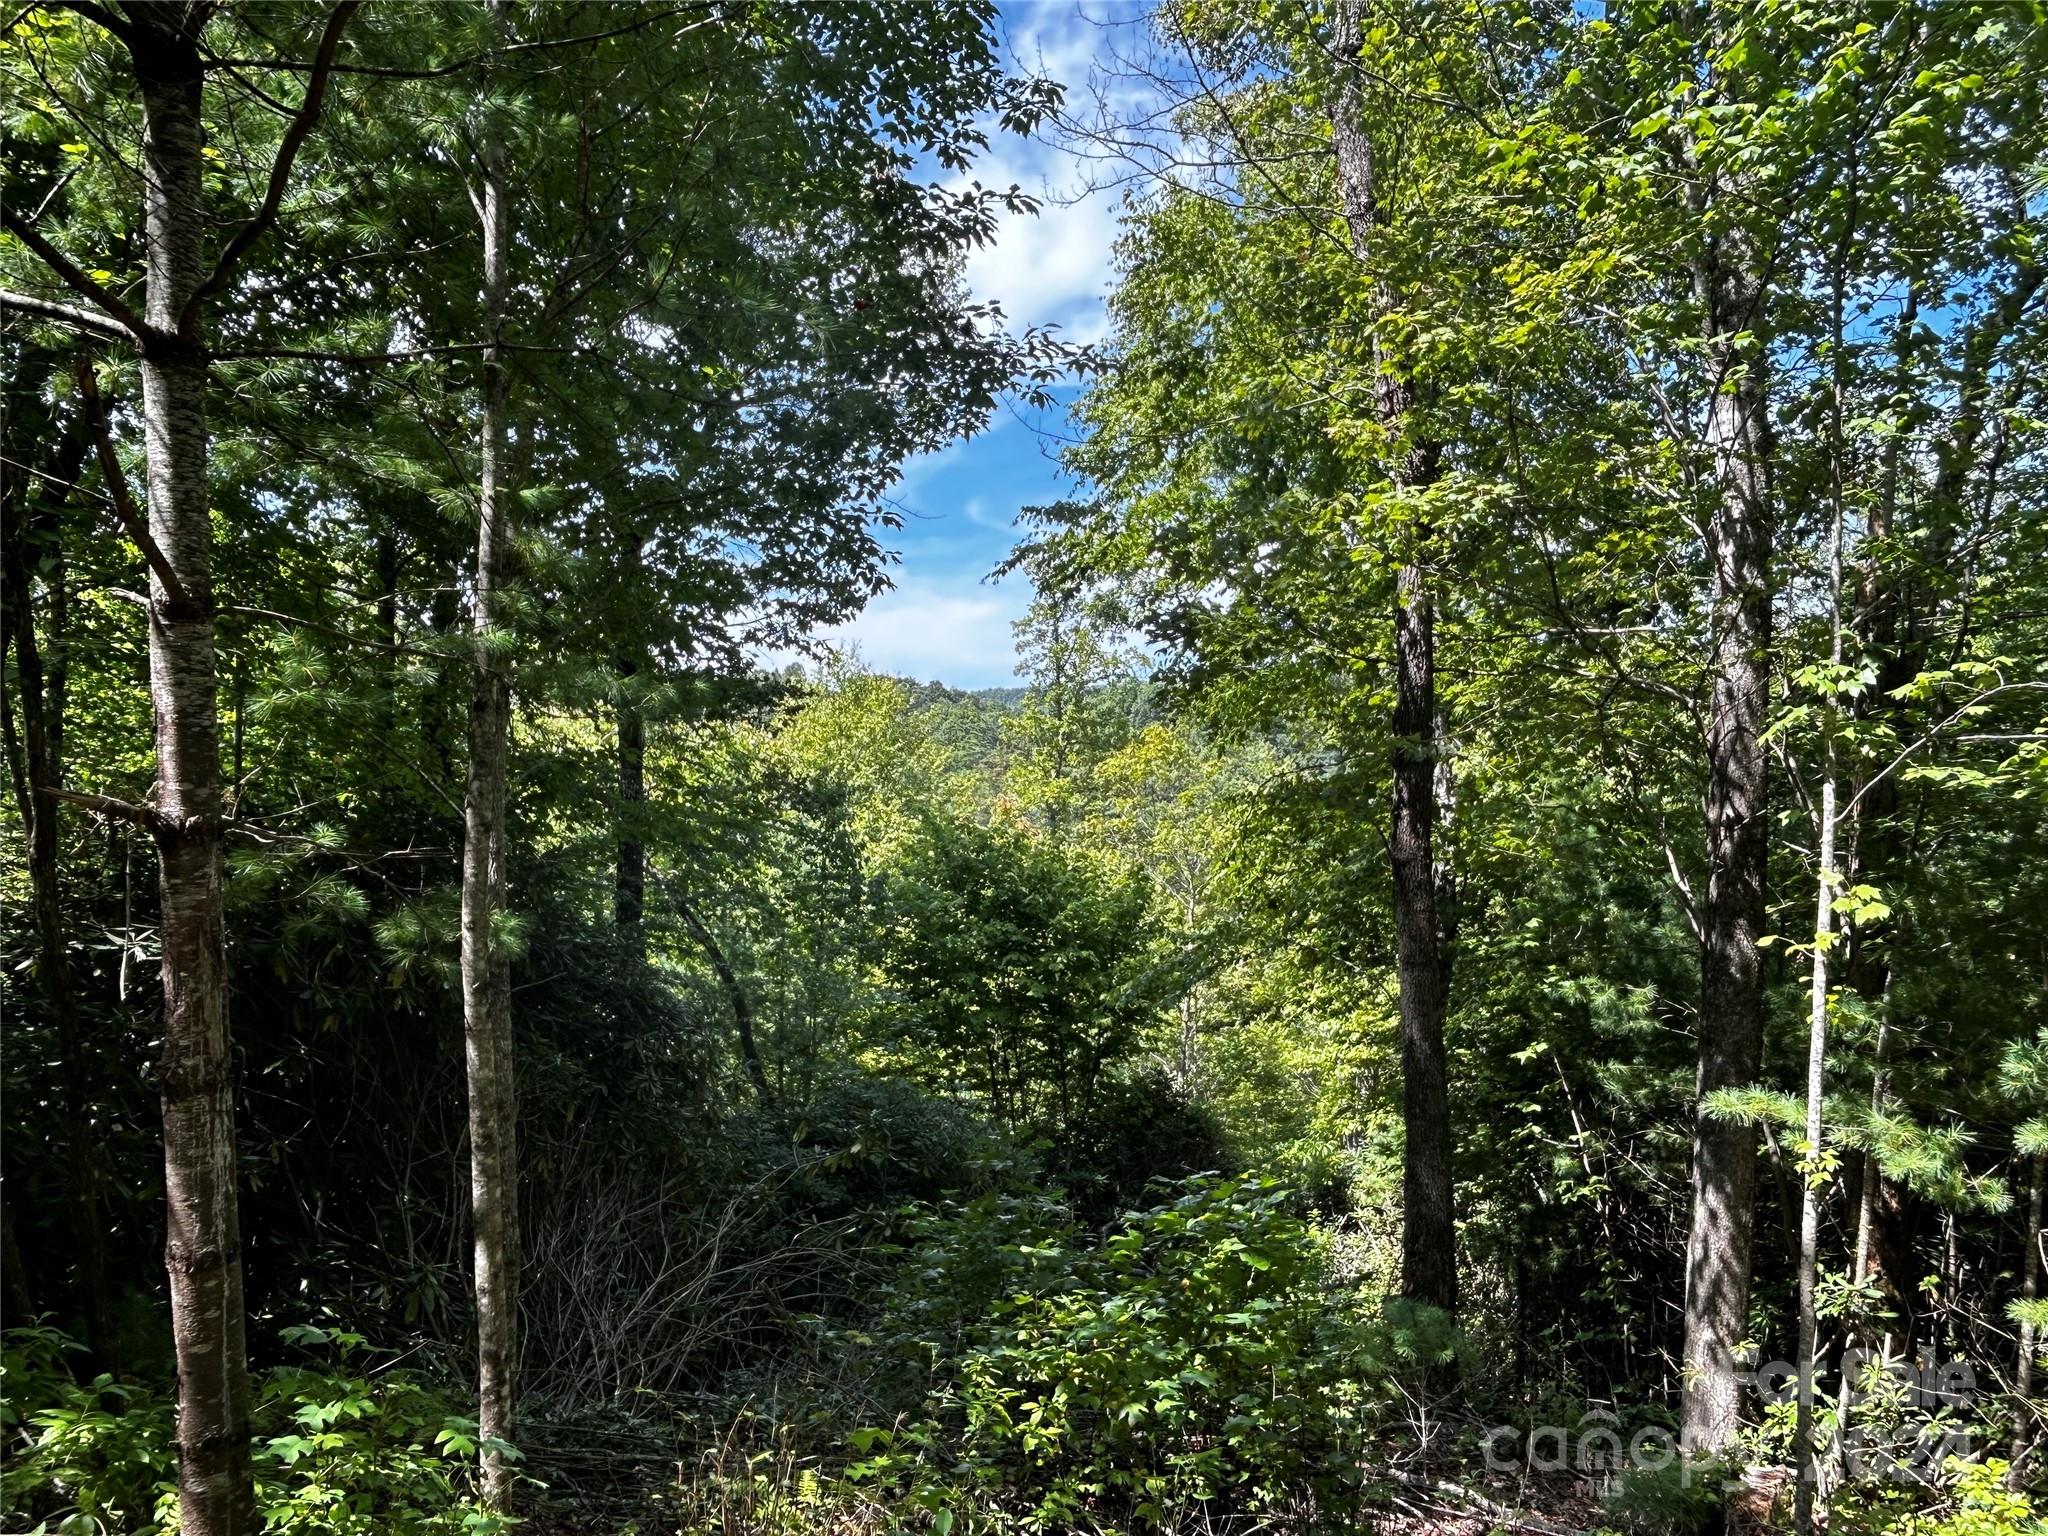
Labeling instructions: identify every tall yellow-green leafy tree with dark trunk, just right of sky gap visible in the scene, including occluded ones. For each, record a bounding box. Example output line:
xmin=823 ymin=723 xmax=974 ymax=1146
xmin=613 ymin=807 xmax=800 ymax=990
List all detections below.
xmin=1047 ymin=6 xmax=1542 ymax=1309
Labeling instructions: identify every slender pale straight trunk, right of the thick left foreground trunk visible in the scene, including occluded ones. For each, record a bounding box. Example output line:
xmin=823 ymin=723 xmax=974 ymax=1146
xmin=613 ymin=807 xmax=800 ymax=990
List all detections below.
xmin=463 ymin=0 xmax=518 ymax=1511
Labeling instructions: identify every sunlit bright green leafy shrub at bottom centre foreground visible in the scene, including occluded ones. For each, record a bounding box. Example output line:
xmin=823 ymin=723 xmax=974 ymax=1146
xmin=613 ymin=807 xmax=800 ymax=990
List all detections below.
xmin=850 ymin=1178 xmax=1405 ymax=1530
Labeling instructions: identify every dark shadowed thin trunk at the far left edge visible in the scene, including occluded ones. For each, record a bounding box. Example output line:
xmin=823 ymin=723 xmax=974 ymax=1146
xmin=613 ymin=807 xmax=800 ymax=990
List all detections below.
xmin=0 ymin=385 xmax=115 ymax=1366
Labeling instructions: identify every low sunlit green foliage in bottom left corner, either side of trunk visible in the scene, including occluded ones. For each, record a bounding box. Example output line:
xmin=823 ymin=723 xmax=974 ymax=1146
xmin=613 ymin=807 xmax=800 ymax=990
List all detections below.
xmin=0 ymin=1325 xmax=518 ymax=1536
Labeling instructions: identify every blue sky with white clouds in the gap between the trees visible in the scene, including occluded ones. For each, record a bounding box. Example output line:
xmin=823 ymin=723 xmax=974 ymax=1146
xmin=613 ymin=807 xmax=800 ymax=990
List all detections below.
xmin=827 ymin=0 xmax=1145 ymax=688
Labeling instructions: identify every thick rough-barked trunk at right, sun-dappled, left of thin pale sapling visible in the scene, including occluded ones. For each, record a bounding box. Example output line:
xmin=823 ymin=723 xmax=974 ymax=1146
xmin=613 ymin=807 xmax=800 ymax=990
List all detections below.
xmin=1679 ymin=138 xmax=1772 ymax=1456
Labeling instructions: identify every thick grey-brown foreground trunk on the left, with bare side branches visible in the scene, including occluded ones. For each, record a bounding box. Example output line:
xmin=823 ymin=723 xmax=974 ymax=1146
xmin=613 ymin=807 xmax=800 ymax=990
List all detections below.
xmin=129 ymin=18 xmax=256 ymax=1536
